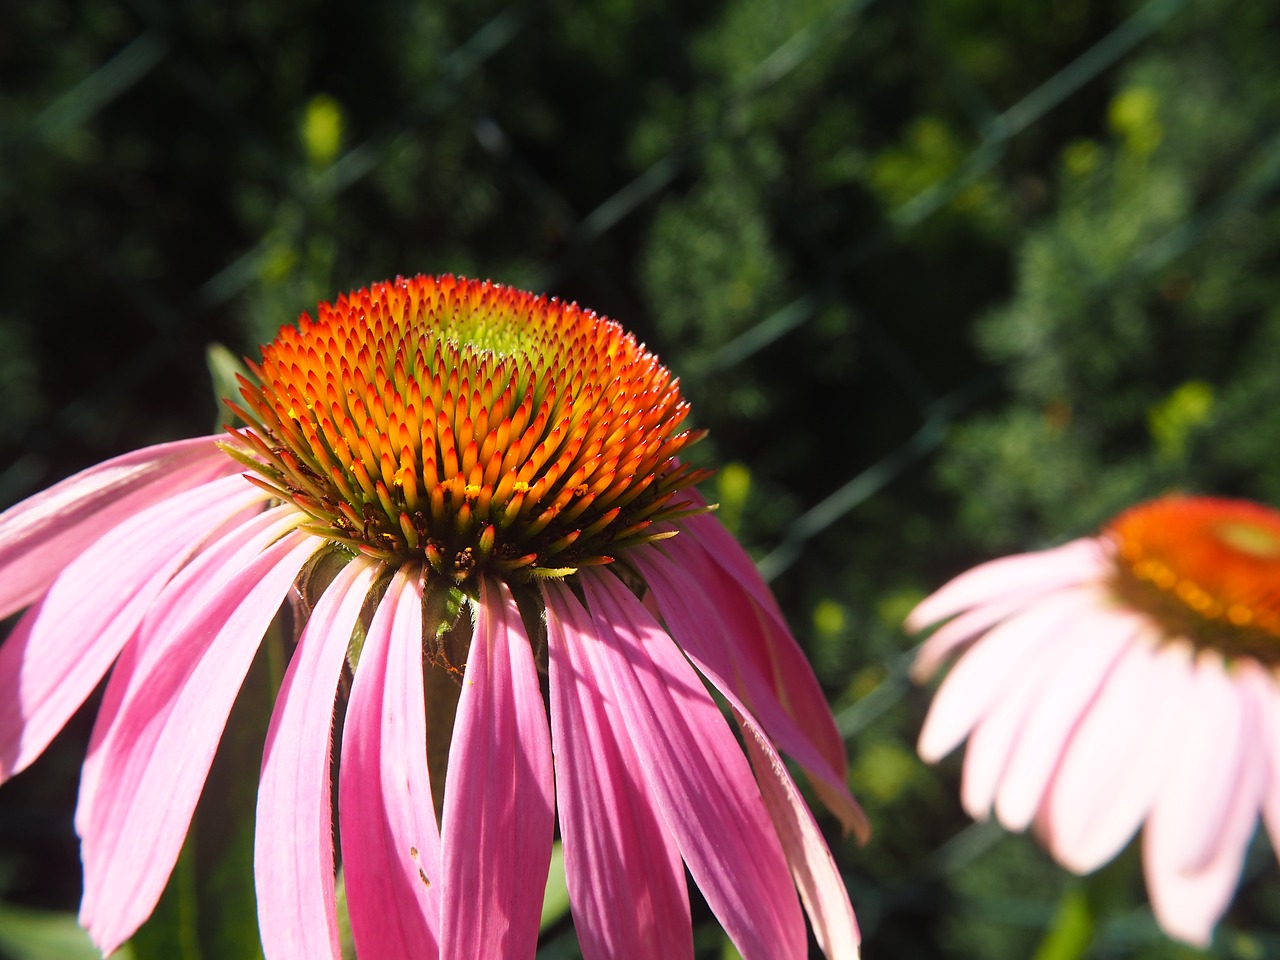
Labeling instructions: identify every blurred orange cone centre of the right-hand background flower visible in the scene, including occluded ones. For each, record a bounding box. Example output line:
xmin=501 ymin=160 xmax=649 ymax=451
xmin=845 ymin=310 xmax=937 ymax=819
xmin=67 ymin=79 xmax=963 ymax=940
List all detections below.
xmin=1107 ymin=497 xmax=1280 ymax=663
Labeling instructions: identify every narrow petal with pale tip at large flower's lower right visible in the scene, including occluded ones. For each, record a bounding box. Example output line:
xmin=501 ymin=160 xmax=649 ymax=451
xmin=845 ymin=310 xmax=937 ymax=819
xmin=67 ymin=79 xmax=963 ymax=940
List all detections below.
xmin=733 ymin=709 xmax=861 ymax=960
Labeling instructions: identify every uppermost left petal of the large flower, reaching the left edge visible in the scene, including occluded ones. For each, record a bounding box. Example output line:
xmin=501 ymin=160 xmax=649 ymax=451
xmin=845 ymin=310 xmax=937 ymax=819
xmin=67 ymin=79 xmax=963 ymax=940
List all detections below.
xmin=0 ymin=436 xmax=243 ymax=620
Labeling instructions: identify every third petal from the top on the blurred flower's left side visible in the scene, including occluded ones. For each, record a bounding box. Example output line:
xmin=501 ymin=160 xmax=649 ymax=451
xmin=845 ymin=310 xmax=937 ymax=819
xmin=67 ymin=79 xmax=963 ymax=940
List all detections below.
xmin=918 ymin=589 xmax=1097 ymax=763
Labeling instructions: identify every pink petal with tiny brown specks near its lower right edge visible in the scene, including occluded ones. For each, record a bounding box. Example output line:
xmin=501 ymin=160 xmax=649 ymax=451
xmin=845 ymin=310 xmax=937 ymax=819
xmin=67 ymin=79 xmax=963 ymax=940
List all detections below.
xmin=338 ymin=567 xmax=442 ymax=960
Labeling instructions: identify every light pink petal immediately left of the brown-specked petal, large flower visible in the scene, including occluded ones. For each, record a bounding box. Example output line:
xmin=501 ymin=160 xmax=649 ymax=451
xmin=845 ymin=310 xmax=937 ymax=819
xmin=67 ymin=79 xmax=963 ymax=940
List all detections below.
xmin=253 ymin=557 xmax=380 ymax=960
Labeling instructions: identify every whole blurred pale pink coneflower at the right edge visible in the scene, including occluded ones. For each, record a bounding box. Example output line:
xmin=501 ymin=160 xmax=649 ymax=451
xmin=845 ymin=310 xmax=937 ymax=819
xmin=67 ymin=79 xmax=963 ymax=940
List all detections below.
xmin=908 ymin=497 xmax=1280 ymax=945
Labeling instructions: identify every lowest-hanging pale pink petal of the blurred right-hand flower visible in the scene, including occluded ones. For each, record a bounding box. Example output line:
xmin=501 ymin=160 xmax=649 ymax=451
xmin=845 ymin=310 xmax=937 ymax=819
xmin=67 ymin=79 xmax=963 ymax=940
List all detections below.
xmin=1143 ymin=654 xmax=1267 ymax=946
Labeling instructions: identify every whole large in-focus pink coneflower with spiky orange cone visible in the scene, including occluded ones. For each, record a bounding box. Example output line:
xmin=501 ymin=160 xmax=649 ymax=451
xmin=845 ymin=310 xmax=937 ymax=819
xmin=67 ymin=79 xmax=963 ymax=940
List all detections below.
xmin=0 ymin=276 xmax=865 ymax=960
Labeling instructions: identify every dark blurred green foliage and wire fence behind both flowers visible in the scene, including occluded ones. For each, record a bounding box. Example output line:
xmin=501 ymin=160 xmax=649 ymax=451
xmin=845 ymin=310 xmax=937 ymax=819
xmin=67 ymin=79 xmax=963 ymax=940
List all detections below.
xmin=0 ymin=0 xmax=1280 ymax=960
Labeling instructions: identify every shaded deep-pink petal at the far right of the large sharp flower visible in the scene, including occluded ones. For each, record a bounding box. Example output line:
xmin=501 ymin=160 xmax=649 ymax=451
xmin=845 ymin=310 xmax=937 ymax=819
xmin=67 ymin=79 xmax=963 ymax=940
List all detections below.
xmin=650 ymin=537 xmax=863 ymax=814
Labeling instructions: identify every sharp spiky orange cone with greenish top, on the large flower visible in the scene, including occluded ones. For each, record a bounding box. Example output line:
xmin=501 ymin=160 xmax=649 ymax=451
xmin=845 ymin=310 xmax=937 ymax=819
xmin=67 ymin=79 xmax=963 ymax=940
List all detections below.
xmin=229 ymin=276 xmax=708 ymax=582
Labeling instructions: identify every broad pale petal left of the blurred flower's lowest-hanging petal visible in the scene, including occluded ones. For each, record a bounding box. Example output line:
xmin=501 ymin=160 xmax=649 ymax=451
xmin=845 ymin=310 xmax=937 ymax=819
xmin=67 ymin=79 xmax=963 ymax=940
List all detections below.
xmin=1036 ymin=636 xmax=1192 ymax=873
